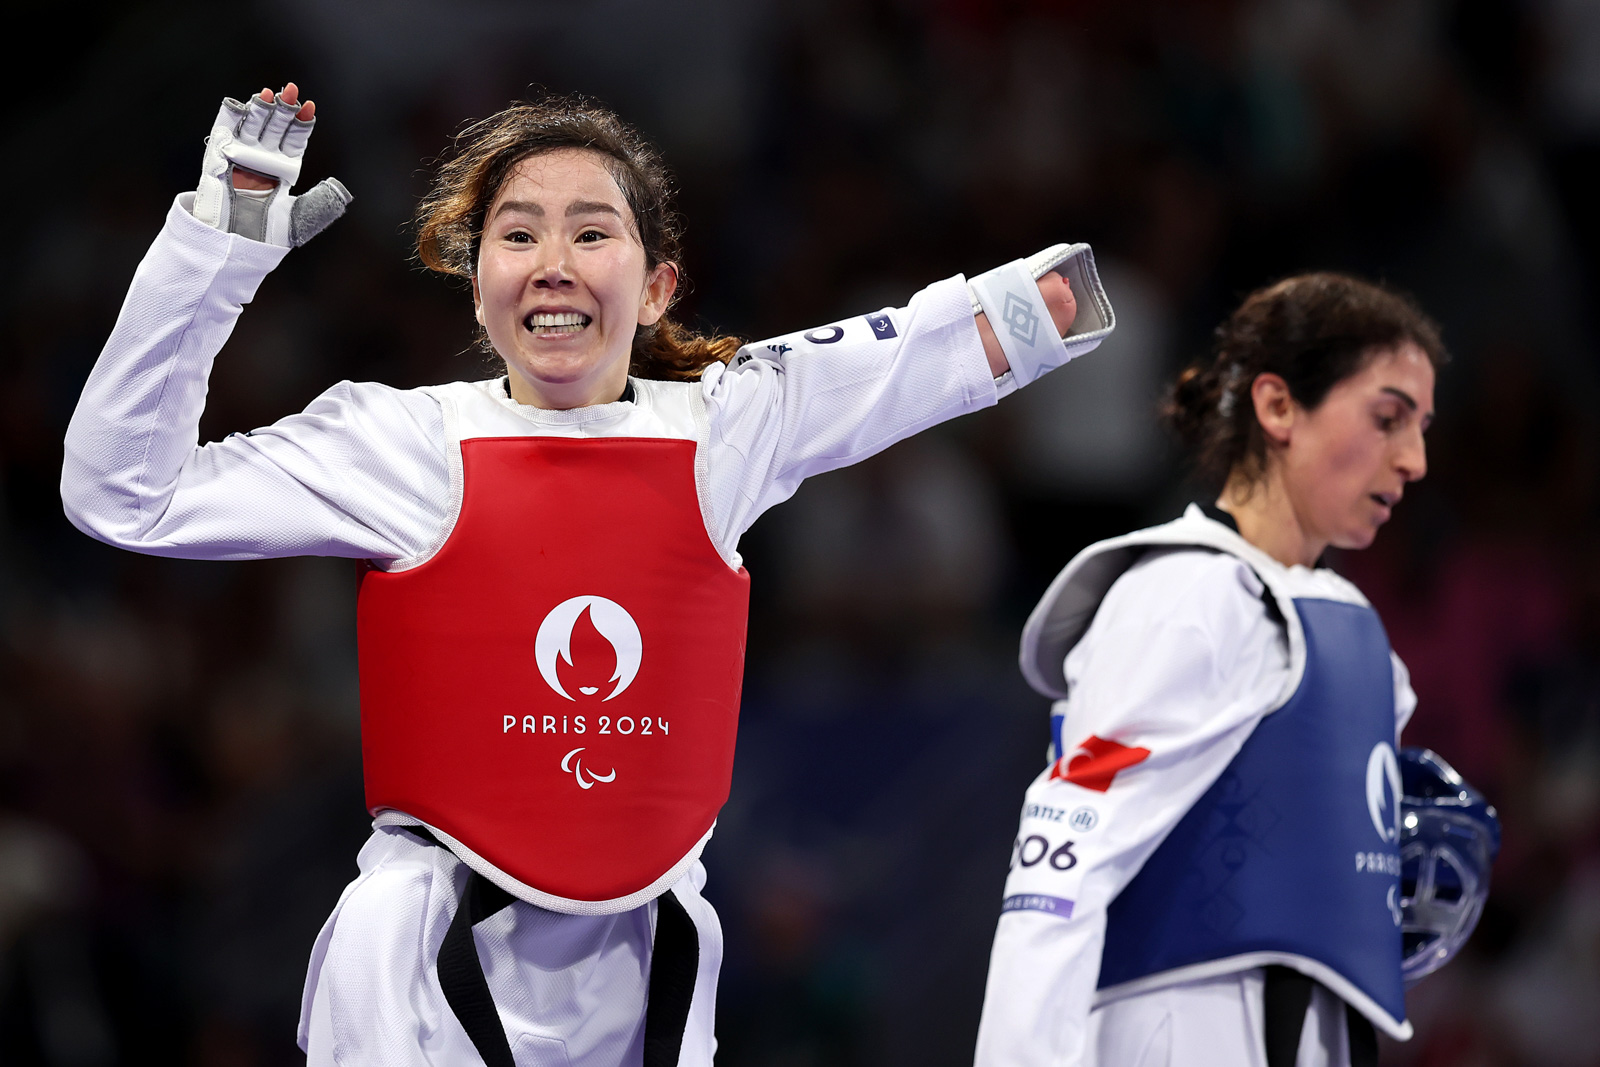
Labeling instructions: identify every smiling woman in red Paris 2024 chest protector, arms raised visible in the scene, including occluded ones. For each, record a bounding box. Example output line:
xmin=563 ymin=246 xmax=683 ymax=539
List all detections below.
xmin=62 ymin=85 xmax=1112 ymax=1067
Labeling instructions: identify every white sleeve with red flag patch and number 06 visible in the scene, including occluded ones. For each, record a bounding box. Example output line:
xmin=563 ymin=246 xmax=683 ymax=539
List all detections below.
xmin=978 ymin=550 xmax=1288 ymax=1067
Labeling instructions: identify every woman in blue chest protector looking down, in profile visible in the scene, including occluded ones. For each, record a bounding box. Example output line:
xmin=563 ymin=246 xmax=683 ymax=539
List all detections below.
xmin=978 ymin=274 xmax=1445 ymax=1067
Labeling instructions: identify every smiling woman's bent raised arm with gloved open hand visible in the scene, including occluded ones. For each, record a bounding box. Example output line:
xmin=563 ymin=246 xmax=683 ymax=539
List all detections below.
xmin=61 ymin=85 xmax=448 ymax=558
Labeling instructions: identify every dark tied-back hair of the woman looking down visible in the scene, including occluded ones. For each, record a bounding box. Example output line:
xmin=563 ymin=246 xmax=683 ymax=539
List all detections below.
xmin=1162 ymin=272 xmax=1450 ymax=488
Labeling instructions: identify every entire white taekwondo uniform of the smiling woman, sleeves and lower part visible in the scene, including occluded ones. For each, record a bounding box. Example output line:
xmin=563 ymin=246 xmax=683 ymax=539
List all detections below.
xmin=61 ymin=198 xmax=1014 ymax=1067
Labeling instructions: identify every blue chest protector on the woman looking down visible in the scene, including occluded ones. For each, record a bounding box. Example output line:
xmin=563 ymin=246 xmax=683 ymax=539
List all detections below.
xmin=1099 ymin=597 xmax=1405 ymax=1030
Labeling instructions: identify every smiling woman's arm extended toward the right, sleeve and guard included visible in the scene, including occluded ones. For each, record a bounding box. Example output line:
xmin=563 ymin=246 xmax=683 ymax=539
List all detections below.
xmin=704 ymin=245 xmax=1114 ymax=544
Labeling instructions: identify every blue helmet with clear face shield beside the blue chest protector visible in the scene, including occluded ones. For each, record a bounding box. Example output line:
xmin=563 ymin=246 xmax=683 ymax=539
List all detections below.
xmin=1400 ymin=749 xmax=1499 ymax=985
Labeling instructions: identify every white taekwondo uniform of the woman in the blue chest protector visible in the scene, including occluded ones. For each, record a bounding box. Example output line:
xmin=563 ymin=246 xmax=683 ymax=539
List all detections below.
xmin=976 ymin=507 xmax=1416 ymax=1067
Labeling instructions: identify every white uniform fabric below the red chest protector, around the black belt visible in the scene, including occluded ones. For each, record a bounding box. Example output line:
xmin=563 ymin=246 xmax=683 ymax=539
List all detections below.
xmin=299 ymin=827 xmax=722 ymax=1067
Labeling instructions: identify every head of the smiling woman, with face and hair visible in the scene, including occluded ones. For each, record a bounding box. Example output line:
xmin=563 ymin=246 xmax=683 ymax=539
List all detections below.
xmin=418 ymin=98 xmax=739 ymax=408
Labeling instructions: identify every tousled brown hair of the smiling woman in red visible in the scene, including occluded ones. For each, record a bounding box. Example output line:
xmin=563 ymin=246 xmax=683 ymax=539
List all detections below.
xmin=416 ymin=94 xmax=739 ymax=381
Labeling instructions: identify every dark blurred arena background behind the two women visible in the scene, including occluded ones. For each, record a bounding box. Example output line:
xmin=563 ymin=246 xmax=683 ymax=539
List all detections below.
xmin=0 ymin=0 xmax=1600 ymax=1067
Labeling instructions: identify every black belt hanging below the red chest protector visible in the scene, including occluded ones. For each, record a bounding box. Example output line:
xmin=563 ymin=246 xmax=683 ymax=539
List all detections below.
xmin=403 ymin=825 xmax=699 ymax=1067
